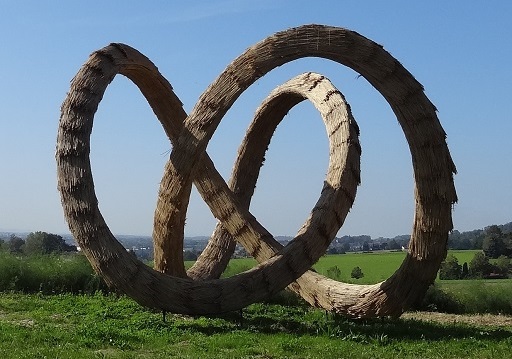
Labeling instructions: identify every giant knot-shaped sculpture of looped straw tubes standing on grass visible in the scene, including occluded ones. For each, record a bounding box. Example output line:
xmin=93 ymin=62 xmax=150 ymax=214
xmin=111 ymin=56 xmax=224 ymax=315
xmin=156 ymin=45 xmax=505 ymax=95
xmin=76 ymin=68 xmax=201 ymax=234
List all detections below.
xmin=56 ymin=25 xmax=457 ymax=317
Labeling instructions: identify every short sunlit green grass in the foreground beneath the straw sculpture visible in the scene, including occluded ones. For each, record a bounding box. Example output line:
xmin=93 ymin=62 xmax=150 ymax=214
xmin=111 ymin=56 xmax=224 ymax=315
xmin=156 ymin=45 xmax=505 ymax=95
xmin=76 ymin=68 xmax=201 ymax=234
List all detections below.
xmin=0 ymin=294 xmax=512 ymax=359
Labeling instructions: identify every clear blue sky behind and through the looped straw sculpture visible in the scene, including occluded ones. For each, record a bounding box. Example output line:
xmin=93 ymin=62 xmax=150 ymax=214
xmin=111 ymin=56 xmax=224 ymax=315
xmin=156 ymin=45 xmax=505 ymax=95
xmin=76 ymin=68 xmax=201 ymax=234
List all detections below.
xmin=0 ymin=0 xmax=512 ymax=237
